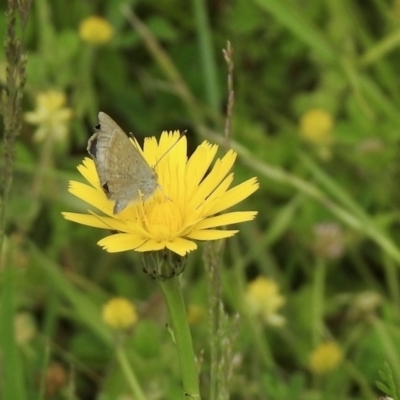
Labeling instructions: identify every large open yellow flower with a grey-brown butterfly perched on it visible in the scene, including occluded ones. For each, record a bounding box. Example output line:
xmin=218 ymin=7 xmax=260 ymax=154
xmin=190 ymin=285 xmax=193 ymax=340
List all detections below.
xmin=63 ymin=131 xmax=259 ymax=256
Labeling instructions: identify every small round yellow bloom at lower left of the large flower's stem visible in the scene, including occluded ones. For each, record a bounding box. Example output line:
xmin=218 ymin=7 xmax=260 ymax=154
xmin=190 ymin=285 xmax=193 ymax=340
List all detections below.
xmin=103 ymin=297 xmax=138 ymax=331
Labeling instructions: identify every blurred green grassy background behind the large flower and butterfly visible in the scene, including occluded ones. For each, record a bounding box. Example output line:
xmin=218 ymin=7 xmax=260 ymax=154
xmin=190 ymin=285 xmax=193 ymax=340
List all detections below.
xmin=0 ymin=0 xmax=400 ymax=400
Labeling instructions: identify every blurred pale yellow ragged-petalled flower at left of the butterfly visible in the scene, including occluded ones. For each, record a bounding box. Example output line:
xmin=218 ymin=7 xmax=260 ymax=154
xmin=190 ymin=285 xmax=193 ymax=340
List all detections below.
xmin=25 ymin=90 xmax=72 ymax=142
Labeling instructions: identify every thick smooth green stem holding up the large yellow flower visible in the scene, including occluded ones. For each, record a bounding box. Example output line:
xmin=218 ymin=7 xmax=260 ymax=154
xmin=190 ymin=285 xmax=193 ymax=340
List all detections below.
xmin=158 ymin=277 xmax=200 ymax=400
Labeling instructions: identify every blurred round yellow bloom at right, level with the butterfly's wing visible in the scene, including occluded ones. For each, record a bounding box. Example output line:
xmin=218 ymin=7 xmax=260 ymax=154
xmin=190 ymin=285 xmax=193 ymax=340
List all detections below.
xmin=300 ymin=108 xmax=333 ymax=145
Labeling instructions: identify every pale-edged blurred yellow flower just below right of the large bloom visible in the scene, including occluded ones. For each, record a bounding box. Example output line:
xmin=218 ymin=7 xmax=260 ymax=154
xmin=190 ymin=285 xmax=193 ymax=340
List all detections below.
xmin=245 ymin=277 xmax=285 ymax=326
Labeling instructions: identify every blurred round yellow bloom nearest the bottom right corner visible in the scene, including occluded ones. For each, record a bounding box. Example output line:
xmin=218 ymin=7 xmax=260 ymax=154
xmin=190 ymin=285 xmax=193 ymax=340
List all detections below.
xmin=309 ymin=342 xmax=343 ymax=375
